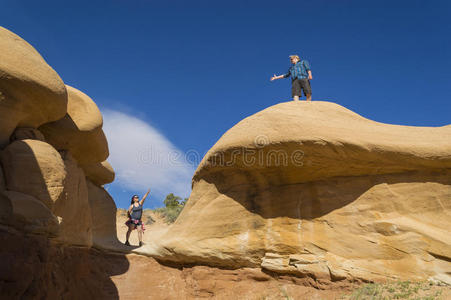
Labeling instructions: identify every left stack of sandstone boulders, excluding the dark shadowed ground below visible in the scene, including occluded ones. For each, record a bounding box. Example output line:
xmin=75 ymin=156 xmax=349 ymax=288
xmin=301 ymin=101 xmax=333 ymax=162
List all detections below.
xmin=0 ymin=27 xmax=116 ymax=247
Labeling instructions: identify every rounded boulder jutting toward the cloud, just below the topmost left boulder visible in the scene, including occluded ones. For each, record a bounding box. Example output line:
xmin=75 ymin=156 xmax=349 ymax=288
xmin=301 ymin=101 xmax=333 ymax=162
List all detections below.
xmin=39 ymin=86 xmax=109 ymax=165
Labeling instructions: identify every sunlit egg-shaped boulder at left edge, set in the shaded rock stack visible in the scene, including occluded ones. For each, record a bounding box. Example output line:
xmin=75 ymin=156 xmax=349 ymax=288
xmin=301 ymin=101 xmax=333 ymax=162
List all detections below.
xmin=1 ymin=139 xmax=67 ymax=209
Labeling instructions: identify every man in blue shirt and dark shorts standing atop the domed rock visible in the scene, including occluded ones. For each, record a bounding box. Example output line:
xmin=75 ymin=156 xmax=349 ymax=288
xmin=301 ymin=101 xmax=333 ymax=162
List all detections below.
xmin=271 ymin=55 xmax=313 ymax=101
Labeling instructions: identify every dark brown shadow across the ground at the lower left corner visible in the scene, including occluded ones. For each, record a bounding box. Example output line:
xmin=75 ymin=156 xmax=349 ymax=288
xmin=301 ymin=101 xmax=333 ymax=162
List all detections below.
xmin=0 ymin=227 xmax=129 ymax=299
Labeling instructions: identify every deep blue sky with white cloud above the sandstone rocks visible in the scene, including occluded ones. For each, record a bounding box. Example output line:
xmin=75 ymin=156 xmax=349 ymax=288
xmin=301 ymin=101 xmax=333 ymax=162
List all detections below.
xmin=0 ymin=0 xmax=451 ymax=208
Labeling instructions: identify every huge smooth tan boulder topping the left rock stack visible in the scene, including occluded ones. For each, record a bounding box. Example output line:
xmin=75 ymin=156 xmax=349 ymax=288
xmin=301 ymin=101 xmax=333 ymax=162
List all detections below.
xmin=0 ymin=27 xmax=67 ymax=148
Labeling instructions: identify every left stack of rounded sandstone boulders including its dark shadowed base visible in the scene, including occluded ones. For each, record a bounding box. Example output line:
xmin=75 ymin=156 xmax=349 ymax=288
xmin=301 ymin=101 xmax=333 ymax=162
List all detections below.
xmin=0 ymin=27 xmax=128 ymax=299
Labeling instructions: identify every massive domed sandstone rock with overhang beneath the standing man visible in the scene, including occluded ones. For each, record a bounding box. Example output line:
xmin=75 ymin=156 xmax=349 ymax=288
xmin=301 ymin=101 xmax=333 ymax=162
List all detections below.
xmin=155 ymin=101 xmax=451 ymax=283
